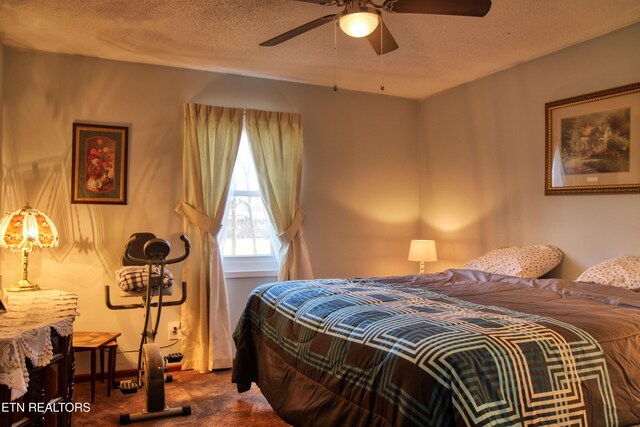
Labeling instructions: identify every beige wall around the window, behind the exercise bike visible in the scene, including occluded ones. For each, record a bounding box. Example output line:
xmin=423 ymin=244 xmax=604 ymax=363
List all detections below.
xmin=0 ymin=47 xmax=419 ymax=373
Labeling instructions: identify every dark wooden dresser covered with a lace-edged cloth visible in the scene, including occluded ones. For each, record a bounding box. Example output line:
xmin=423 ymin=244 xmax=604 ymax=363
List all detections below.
xmin=0 ymin=290 xmax=78 ymax=427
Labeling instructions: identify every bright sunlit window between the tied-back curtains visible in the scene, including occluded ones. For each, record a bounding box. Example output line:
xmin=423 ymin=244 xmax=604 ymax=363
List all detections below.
xmin=219 ymin=131 xmax=279 ymax=277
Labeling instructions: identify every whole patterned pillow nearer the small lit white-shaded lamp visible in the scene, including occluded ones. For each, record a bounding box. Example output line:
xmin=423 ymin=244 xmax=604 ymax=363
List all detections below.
xmin=464 ymin=245 xmax=562 ymax=279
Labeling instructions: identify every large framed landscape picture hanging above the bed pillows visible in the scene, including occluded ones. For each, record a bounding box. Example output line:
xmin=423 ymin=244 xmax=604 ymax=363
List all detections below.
xmin=545 ymin=83 xmax=640 ymax=195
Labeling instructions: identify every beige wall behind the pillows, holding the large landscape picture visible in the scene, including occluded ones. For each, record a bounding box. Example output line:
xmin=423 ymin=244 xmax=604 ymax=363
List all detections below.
xmin=418 ymin=24 xmax=640 ymax=279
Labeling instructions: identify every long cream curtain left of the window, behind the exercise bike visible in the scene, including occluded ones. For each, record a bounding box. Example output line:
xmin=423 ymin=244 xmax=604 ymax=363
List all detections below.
xmin=176 ymin=104 xmax=243 ymax=372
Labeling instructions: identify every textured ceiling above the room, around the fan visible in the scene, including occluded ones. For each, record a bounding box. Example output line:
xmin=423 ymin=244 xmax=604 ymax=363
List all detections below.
xmin=0 ymin=0 xmax=640 ymax=99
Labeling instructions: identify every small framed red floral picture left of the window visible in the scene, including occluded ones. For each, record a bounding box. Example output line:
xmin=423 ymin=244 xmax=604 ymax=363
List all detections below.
xmin=71 ymin=123 xmax=129 ymax=205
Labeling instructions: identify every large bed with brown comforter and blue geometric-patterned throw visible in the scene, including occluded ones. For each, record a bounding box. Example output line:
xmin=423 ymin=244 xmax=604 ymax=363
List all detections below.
xmin=232 ymin=269 xmax=640 ymax=426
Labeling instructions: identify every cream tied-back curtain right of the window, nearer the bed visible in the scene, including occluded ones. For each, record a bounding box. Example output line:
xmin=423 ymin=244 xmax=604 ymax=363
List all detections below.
xmin=246 ymin=110 xmax=313 ymax=280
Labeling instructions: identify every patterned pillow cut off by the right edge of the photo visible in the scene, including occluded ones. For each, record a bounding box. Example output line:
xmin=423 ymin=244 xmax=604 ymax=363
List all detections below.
xmin=576 ymin=255 xmax=640 ymax=290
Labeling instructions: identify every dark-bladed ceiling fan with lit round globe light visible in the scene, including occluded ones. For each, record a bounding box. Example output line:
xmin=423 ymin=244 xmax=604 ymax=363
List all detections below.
xmin=260 ymin=0 xmax=491 ymax=55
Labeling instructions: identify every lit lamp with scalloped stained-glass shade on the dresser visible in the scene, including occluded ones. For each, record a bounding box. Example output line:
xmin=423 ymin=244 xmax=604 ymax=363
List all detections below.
xmin=0 ymin=202 xmax=59 ymax=291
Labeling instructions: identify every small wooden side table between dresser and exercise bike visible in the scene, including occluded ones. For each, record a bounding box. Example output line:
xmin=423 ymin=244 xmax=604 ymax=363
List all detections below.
xmin=73 ymin=331 xmax=121 ymax=403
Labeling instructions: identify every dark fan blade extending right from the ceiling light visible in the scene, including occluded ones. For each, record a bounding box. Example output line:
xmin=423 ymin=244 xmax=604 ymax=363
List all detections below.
xmin=382 ymin=0 xmax=491 ymax=16
